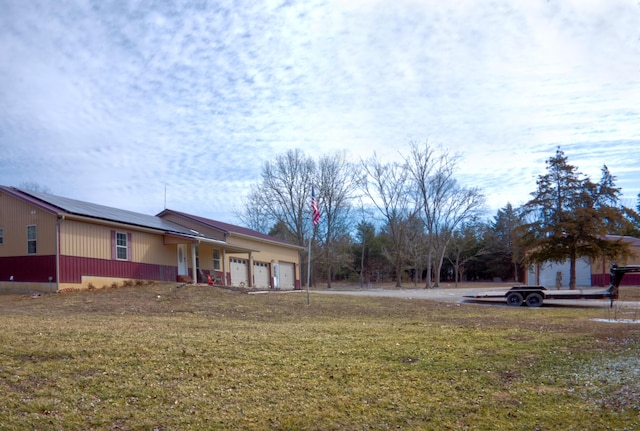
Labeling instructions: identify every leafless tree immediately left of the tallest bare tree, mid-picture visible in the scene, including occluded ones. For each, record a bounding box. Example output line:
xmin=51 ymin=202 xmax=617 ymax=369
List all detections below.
xmin=362 ymin=154 xmax=414 ymax=287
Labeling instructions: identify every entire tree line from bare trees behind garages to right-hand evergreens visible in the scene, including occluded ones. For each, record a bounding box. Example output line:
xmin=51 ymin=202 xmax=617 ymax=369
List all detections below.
xmin=237 ymin=142 xmax=640 ymax=288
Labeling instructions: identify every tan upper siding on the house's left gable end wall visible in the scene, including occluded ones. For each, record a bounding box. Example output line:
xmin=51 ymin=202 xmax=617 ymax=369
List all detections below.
xmin=0 ymin=193 xmax=57 ymax=256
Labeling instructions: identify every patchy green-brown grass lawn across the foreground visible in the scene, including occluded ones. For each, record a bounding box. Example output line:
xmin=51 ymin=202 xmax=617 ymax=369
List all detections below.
xmin=0 ymin=284 xmax=640 ymax=430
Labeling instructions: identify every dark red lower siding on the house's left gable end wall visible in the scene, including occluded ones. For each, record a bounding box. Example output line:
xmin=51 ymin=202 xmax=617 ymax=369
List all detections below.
xmin=0 ymin=255 xmax=56 ymax=283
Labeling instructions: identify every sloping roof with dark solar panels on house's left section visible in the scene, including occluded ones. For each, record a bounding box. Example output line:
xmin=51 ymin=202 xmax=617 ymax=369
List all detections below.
xmin=13 ymin=188 xmax=198 ymax=236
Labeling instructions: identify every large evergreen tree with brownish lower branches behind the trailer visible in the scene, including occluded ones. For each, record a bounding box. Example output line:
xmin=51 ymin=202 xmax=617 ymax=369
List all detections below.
xmin=521 ymin=148 xmax=629 ymax=289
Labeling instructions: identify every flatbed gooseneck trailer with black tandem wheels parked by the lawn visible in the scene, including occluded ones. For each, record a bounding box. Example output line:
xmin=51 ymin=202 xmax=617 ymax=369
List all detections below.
xmin=464 ymin=264 xmax=640 ymax=307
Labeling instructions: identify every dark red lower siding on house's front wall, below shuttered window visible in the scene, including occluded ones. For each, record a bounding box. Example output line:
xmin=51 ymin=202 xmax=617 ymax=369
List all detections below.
xmin=60 ymin=256 xmax=178 ymax=283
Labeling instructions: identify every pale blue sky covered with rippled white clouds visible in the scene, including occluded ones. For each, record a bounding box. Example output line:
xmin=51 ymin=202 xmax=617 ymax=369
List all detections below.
xmin=0 ymin=0 xmax=640 ymax=223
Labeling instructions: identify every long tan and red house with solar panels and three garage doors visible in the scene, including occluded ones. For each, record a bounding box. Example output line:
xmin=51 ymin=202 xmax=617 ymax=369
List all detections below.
xmin=0 ymin=186 xmax=302 ymax=292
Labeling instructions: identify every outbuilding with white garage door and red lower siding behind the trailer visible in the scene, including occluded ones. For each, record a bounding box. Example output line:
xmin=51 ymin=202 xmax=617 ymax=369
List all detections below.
xmin=525 ymin=235 xmax=640 ymax=288
